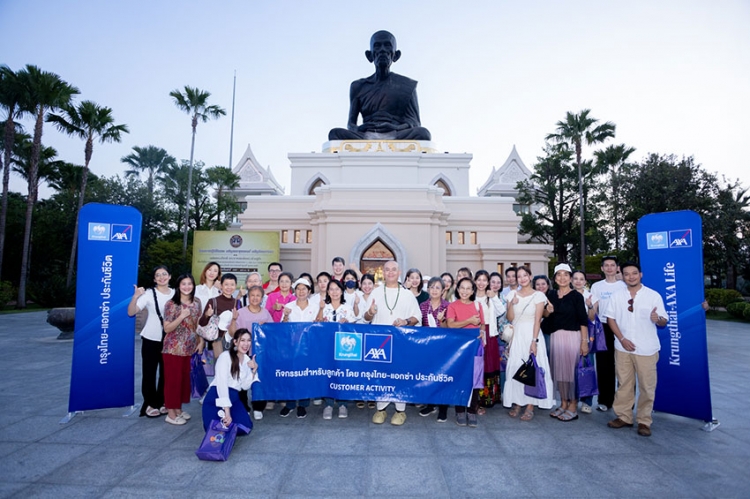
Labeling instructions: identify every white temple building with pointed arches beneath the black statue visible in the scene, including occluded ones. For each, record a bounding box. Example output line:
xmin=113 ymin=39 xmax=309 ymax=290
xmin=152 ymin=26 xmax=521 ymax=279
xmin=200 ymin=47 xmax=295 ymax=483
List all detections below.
xmin=233 ymin=140 xmax=551 ymax=278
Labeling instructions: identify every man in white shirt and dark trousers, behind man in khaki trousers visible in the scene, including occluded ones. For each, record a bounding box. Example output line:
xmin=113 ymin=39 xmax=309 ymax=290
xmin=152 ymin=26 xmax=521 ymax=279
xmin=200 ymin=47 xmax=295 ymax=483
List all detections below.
xmin=586 ymin=255 xmax=627 ymax=412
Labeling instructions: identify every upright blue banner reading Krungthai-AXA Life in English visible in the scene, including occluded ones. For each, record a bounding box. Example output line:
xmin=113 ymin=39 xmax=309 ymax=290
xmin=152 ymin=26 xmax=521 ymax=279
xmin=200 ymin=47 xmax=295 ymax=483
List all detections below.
xmin=638 ymin=211 xmax=713 ymax=421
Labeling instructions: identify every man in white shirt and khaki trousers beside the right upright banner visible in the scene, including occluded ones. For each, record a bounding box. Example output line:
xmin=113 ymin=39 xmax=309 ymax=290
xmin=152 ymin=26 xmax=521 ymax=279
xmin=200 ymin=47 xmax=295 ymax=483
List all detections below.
xmin=606 ymin=262 xmax=667 ymax=437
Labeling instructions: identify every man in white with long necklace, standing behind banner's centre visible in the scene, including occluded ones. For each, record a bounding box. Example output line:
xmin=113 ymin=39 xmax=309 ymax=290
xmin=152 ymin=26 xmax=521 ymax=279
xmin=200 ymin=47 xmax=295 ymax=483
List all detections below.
xmin=364 ymin=260 xmax=422 ymax=426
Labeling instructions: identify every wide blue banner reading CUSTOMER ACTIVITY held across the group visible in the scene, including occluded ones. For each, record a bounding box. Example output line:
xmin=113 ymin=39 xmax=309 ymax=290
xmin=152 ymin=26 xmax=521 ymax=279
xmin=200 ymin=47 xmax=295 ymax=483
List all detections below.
xmin=253 ymin=322 xmax=479 ymax=405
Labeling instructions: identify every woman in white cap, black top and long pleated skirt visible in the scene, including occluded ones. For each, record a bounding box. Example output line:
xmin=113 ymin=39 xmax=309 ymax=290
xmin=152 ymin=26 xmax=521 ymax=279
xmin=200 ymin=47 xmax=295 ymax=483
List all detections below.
xmin=547 ymin=263 xmax=589 ymax=421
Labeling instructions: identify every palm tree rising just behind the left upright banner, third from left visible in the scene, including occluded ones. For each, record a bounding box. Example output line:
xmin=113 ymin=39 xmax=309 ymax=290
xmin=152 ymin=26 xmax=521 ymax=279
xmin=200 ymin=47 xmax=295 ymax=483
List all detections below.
xmin=47 ymin=100 xmax=130 ymax=287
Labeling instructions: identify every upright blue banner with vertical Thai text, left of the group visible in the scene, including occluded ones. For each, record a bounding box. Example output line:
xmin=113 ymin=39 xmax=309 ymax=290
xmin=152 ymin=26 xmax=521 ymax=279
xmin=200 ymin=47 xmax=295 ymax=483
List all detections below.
xmin=68 ymin=203 xmax=141 ymax=412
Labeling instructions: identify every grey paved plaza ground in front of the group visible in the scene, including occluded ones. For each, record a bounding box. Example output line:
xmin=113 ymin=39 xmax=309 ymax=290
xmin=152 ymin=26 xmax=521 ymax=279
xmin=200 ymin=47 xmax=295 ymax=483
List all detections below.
xmin=0 ymin=313 xmax=750 ymax=498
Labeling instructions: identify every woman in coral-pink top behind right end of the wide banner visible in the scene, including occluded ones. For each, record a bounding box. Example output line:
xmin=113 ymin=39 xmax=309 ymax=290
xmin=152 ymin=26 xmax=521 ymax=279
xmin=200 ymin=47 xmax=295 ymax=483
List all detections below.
xmin=446 ymin=277 xmax=484 ymax=428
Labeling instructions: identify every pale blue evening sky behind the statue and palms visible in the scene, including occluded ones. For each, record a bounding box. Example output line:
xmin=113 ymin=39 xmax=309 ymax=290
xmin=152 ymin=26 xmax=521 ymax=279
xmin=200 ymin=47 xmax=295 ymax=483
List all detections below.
xmin=0 ymin=0 xmax=750 ymax=195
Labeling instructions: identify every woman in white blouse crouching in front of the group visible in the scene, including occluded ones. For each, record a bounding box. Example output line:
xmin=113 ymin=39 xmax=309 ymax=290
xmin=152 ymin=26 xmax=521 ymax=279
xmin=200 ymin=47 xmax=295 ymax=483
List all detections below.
xmin=203 ymin=328 xmax=258 ymax=435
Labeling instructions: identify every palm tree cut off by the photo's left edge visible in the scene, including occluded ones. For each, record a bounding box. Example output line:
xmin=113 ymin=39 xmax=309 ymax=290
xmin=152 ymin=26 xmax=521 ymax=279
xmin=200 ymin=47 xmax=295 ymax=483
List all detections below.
xmin=0 ymin=64 xmax=27 ymax=280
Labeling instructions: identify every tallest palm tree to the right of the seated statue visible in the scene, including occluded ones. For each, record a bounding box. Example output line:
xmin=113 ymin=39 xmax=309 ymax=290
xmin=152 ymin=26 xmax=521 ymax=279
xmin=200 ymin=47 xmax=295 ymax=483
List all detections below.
xmin=546 ymin=109 xmax=615 ymax=272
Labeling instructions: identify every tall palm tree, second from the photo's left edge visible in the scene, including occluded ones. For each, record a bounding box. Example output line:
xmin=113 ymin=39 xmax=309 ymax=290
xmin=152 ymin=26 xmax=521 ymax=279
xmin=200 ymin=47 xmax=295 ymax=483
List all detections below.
xmin=17 ymin=64 xmax=80 ymax=308
